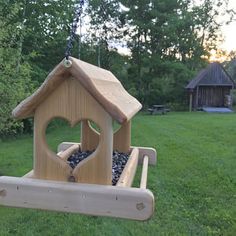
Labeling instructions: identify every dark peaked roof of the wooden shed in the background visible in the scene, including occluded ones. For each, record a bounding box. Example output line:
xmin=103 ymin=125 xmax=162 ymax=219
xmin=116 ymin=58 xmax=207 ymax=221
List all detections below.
xmin=186 ymin=62 xmax=234 ymax=89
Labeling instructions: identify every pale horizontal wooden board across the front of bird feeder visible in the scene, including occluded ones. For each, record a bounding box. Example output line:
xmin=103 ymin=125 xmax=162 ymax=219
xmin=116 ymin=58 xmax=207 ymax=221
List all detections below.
xmin=0 ymin=176 xmax=154 ymax=220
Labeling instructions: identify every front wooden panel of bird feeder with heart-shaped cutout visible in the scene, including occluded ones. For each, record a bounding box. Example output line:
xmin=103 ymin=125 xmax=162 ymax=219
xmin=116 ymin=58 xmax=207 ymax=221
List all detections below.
xmin=34 ymin=77 xmax=113 ymax=184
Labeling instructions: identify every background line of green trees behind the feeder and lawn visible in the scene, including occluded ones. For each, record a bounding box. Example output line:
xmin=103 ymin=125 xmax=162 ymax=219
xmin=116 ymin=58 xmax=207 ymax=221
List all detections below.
xmin=0 ymin=0 xmax=236 ymax=137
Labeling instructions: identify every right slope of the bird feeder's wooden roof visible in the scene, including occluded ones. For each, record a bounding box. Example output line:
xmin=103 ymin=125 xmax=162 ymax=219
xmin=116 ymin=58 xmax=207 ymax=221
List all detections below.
xmin=70 ymin=58 xmax=142 ymax=124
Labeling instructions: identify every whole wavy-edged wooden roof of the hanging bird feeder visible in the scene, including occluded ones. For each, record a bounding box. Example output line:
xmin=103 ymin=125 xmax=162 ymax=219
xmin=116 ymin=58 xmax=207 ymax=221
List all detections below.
xmin=12 ymin=57 xmax=142 ymax=123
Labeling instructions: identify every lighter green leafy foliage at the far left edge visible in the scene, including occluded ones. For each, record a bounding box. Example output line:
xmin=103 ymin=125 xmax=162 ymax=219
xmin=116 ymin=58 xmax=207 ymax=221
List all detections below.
xmin=0 ymin=1 xmax=32 ymax=137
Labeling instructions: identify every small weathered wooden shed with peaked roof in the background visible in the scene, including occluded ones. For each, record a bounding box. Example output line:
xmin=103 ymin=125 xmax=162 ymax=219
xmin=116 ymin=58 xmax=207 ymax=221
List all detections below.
xmin=186 ymin=62 xmax=234 ymax=111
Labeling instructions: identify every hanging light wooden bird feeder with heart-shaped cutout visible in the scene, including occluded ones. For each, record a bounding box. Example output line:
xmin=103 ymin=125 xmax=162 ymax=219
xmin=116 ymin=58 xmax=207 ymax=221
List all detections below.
xmin=0 ymin=57 xmax=156 ymax=220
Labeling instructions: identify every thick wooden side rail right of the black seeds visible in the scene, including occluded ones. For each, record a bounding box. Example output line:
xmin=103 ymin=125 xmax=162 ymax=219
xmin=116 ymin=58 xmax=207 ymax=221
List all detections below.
xmin=116 ymin=148 xmax=139 ymax=187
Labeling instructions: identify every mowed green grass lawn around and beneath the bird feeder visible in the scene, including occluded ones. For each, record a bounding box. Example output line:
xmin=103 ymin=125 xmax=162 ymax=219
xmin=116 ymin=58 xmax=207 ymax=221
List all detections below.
xmin=0 ymin=112 xmax=236 ymax=236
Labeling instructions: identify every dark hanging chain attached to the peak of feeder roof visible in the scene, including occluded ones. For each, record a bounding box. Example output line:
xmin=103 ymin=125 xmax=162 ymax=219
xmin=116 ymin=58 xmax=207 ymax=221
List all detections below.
xmin=64 ymin=0 xmax=84 ymax=67
